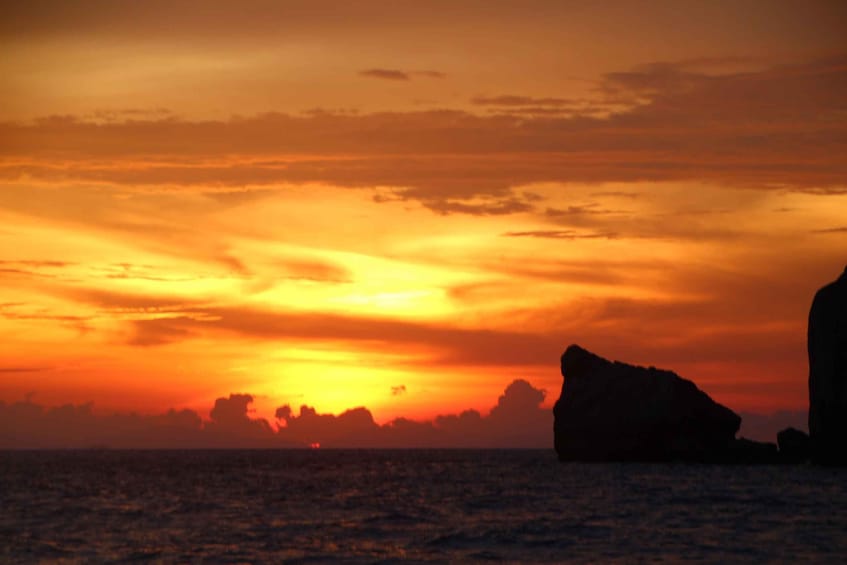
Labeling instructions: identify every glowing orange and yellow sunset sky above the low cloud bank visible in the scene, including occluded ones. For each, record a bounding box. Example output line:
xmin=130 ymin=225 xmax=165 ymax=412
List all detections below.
xmin=0 ymin=0 xmax=847 ymax=428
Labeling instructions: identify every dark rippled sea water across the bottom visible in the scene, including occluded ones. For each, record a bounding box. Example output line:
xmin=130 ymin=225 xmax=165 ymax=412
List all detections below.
xmin=0 ymin=450 xmax=847 ymax=563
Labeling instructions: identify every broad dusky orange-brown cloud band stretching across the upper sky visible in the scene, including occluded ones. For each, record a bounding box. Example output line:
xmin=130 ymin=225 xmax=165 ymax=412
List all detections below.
xmin=0 ymin=54 xmax=847 ymax=214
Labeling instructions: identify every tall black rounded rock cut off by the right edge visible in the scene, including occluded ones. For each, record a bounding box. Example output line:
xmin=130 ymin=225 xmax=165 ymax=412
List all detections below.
xmin=808 ymin=269 xmax=847 ymax=465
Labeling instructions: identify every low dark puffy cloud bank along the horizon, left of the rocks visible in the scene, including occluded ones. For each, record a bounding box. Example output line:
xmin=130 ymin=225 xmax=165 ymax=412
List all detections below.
xmin=0 ymin=380 xmax=553 ymax=449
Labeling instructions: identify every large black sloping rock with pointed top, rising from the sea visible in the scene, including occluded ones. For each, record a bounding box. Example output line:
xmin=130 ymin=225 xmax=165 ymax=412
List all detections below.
xmin=553 ymin=345 xmax=740 ymax=462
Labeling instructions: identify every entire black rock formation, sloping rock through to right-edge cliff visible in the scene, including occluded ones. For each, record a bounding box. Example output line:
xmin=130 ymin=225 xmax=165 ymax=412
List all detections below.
xmin=553 ymin=269 xmax=847 ymax=465
